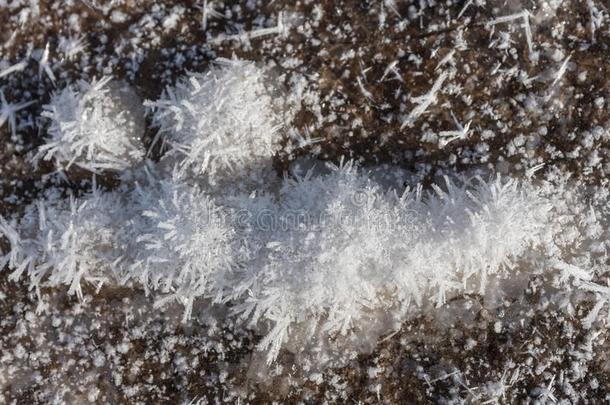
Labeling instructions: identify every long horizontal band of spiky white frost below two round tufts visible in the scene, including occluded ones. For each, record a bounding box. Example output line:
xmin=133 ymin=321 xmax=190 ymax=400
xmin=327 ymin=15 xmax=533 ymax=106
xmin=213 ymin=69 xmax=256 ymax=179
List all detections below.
xmin=0 ymin=159 xmax=590 ymax=361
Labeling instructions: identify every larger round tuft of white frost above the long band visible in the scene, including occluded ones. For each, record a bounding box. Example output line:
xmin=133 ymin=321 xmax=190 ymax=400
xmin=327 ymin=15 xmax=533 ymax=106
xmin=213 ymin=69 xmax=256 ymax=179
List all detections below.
xmin=146 ymin=60 xmax=280 ymax=183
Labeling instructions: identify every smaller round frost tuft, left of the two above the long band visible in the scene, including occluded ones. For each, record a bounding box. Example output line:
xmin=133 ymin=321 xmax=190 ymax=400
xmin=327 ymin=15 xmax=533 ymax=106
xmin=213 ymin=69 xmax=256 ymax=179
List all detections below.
xmin=34 ymin=77 xmax=144 ymax=172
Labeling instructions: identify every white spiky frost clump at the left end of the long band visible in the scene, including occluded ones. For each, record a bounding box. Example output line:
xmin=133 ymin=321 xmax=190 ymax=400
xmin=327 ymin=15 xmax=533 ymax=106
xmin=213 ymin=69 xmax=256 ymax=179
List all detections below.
xmin=0 ymin=190 xmax=130 ymax=297
